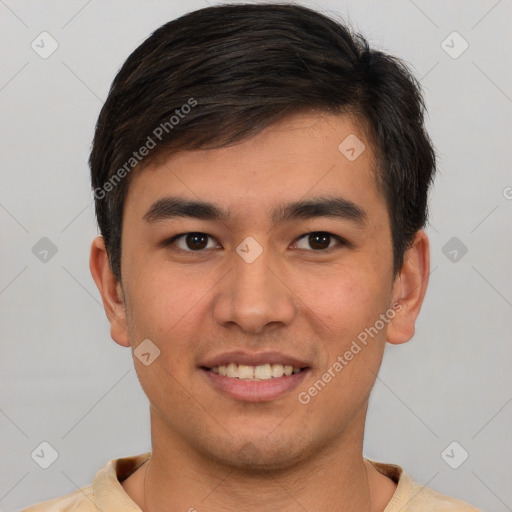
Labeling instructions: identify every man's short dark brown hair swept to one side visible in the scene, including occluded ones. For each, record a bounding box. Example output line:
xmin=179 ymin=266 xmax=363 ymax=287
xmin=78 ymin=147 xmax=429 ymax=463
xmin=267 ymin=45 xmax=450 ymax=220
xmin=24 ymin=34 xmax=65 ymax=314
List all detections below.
xmin=89 ymin=3 xmax=435 ymax=280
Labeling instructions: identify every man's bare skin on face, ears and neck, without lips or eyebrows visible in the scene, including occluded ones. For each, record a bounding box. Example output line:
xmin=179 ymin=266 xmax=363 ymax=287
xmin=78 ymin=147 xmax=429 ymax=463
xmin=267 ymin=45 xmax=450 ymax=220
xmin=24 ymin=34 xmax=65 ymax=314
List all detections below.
xmin=90 ymin=112 xmax=430 ymax=512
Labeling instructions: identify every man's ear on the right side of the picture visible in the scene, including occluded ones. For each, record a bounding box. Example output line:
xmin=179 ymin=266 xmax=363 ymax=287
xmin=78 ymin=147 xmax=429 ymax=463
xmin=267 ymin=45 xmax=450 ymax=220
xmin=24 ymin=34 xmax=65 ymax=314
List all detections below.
xmin=386 ymin=230 xmax=430 ymax=344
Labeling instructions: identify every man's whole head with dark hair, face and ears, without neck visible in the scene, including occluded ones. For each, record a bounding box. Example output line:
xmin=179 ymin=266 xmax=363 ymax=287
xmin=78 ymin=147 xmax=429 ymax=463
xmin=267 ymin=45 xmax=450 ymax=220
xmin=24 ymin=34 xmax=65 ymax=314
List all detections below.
xmin=91 ymin=4 xmax=434 ymax=469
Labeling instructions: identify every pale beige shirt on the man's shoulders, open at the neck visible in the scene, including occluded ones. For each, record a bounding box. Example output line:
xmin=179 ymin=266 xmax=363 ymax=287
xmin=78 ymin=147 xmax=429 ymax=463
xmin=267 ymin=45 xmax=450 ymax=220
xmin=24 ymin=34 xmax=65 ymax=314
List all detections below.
xmin=22 ymin=452 xmax=479 ymax=512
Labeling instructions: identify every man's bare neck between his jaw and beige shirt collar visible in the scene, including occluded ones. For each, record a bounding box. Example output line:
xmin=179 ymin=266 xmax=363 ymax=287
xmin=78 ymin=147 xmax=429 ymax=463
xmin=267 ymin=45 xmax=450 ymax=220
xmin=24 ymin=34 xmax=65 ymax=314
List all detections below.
xmin=123 ymin=404 xmax=395 ymax=512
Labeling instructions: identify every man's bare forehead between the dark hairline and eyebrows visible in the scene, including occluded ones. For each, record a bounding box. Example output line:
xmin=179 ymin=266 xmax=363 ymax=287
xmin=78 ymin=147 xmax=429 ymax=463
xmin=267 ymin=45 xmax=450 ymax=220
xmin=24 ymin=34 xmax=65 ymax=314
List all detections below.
xmin=125 ymin=112 xmax=382 ymax=223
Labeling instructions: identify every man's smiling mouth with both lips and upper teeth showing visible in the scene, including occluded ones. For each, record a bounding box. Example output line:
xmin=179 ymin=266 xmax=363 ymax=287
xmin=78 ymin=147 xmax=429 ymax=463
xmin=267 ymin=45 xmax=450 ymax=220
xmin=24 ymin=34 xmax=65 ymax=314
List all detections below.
xmin=199 ymin=352 xmax=311 ymax=402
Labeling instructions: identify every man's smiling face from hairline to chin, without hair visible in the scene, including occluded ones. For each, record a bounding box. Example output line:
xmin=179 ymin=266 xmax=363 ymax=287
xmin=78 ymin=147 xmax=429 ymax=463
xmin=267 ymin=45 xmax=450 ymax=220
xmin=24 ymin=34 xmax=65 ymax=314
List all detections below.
xmin=91 ymin=113 xmax=424 ymax=469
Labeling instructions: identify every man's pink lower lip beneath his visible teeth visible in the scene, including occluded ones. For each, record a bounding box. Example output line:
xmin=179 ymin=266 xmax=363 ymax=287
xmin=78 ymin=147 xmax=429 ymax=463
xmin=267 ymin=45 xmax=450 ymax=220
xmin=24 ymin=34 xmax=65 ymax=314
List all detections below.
xmin=201 ymin=368 xmax=309 ymax=402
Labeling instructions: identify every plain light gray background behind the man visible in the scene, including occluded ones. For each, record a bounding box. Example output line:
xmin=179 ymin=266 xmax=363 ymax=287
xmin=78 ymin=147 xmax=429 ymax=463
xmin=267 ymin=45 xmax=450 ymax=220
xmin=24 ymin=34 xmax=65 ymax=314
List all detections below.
xmin=0 ymin=0 xmax=512 ymax=512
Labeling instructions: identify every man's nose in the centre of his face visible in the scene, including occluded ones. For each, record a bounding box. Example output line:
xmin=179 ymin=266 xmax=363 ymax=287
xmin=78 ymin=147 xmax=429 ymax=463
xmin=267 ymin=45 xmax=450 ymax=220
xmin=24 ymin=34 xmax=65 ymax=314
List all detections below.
xmin=214 ymin=242 xmax=297 ymax=334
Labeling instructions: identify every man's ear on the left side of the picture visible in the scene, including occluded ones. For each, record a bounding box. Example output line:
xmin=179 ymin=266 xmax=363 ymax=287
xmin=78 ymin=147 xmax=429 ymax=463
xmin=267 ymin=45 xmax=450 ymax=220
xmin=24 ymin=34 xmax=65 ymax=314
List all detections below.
xmin=89 ymin=236 xmax=130 ymax=347
